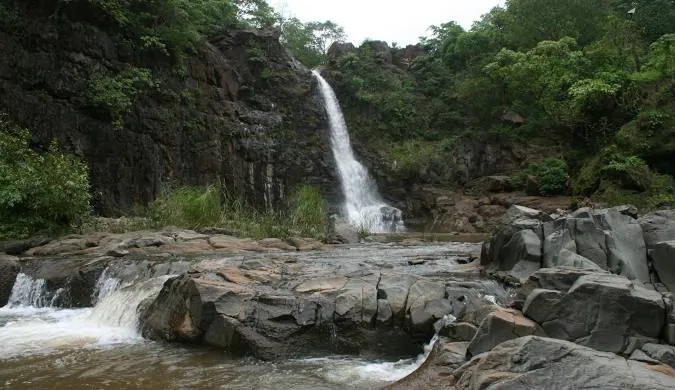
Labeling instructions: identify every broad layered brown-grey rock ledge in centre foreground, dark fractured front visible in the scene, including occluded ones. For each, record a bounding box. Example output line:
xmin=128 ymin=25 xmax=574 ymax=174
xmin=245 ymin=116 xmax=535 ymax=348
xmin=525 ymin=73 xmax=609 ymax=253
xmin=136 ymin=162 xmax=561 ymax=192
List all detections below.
xmin=141 ymin=244 xmax=508 ymax=359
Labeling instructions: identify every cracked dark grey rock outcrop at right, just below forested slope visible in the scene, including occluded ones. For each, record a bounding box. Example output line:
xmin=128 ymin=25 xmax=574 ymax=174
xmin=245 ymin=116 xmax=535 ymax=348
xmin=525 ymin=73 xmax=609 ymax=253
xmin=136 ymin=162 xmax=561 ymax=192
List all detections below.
xmin=481 ymin=206 xmax=651 ymax=284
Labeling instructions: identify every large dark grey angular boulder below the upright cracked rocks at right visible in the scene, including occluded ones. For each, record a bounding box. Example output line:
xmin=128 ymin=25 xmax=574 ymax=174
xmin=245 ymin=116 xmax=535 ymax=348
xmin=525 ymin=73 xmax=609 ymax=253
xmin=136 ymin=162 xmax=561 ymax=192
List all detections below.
xmin=536 ymin=273 xmax=666 ymax=353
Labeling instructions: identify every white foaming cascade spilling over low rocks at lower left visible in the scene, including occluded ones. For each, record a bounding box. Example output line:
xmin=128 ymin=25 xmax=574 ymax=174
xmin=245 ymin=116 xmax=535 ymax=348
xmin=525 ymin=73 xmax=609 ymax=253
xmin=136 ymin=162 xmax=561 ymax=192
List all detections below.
xmin=0 ymin=273 xmax=168 ymax=360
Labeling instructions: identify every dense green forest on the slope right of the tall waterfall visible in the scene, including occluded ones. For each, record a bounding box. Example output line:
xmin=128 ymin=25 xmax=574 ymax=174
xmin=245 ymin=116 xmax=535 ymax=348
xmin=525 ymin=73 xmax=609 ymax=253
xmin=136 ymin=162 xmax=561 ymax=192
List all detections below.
xmin=322 ymin=0 xmax=675 ymax=207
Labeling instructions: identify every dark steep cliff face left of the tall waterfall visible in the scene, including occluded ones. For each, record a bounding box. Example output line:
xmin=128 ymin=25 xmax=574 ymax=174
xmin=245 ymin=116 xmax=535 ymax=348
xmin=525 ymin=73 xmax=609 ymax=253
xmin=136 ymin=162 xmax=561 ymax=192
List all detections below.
xmin=0 ymin=0 xmax=339 ymax=215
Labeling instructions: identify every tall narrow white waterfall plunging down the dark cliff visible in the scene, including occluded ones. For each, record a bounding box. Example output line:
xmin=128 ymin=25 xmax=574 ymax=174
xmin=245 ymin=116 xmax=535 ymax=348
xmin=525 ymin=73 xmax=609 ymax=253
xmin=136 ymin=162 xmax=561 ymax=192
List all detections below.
xmin=312 ymin=69 xmax=405 ymax=233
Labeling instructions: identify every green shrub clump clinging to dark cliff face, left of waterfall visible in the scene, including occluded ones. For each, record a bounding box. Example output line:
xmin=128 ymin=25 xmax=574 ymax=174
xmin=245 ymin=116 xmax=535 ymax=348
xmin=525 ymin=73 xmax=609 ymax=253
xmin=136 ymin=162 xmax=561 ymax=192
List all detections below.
xmin=90 ymin=67 xmax=156 ymax=129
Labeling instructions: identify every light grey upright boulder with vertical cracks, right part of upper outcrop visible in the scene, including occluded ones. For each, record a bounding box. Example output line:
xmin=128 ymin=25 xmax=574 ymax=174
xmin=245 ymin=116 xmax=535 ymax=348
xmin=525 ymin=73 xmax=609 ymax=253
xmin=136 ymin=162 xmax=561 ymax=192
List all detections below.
xmin=543 ymin=209 xmax=650 ymax=282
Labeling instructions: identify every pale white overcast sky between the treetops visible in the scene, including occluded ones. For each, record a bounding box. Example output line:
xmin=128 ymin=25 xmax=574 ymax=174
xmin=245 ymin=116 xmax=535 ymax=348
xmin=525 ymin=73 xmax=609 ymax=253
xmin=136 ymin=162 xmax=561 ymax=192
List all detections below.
xmin=268 ymin=0 xmax=504 ymax=46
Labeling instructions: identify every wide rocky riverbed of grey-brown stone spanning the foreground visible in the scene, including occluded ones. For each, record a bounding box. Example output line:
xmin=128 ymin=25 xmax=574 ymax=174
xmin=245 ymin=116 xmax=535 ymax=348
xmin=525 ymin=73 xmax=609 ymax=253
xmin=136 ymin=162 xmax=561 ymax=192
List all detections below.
xmin=0 ymin=206 xmax=675 ymax=389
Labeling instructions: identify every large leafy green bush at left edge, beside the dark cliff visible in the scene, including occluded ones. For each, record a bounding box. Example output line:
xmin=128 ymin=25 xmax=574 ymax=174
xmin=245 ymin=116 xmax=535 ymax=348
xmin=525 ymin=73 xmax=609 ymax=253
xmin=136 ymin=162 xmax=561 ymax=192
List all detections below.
xmin=0 ymin=116 xmax=91 ymax=240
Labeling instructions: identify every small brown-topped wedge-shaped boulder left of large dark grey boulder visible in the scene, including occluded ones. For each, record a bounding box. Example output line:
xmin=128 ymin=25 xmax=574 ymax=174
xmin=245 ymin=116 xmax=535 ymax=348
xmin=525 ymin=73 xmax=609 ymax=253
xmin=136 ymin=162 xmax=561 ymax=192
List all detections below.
xmin=466 ymin=309 xmax=544 ymax=359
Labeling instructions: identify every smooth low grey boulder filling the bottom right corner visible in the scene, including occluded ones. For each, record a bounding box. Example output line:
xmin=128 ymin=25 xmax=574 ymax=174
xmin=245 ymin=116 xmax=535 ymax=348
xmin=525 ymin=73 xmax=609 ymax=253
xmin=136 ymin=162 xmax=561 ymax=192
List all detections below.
xmin=454 ymin=336 xmax=675 ymax=390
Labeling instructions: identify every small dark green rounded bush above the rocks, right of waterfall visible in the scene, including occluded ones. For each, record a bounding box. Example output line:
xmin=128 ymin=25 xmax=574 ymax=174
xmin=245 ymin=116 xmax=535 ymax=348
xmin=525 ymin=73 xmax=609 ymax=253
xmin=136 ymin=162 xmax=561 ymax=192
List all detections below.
xmin=511 ymin=158 xmax=569 ymax=196
